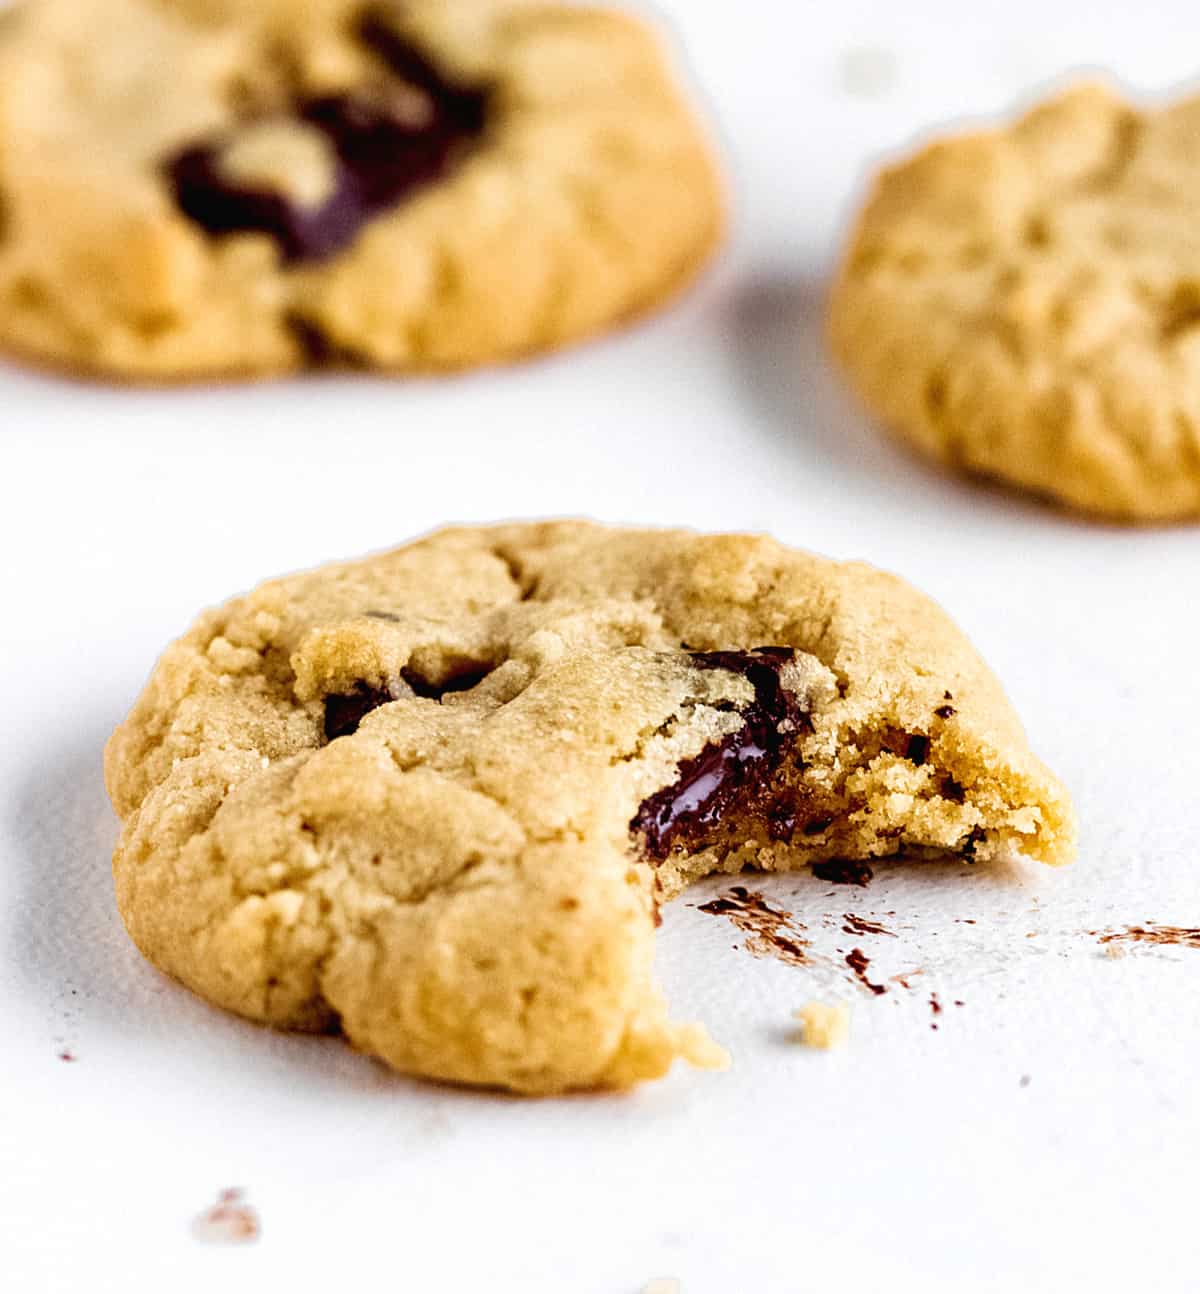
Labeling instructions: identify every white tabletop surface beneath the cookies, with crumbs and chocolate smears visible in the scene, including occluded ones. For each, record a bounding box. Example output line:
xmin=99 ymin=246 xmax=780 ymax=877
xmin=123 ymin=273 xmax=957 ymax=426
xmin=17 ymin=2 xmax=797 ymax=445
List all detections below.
xmin=0 ymin=0 xmax=1200 ymax=1294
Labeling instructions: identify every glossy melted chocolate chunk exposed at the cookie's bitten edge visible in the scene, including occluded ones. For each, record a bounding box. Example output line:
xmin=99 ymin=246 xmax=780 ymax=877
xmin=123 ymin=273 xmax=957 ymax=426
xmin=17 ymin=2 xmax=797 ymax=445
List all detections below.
xmin=629 ymin=647 xmax=808 ymax=861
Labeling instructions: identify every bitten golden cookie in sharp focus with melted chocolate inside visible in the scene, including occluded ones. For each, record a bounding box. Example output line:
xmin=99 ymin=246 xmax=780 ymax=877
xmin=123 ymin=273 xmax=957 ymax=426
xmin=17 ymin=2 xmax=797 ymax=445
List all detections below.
xmin=106 ymin=521 xmax=1074 ymax=1092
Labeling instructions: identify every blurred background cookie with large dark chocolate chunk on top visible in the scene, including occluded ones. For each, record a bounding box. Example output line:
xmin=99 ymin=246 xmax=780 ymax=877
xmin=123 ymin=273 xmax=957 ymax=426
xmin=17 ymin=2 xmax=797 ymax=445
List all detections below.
xmin=0 ymin=0 xmax=722 ymax=380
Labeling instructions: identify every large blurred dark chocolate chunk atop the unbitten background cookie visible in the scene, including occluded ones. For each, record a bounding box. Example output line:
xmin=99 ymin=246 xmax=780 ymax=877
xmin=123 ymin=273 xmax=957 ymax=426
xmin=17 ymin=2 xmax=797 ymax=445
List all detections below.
xmin=166 ymin=18 xmax=488 ymax=264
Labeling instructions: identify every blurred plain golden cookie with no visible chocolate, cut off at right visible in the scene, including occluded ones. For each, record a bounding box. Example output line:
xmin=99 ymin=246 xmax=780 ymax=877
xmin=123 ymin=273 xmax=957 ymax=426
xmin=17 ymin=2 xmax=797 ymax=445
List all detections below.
xmin=830 ymin=85 xmax=1200 ymax=521
